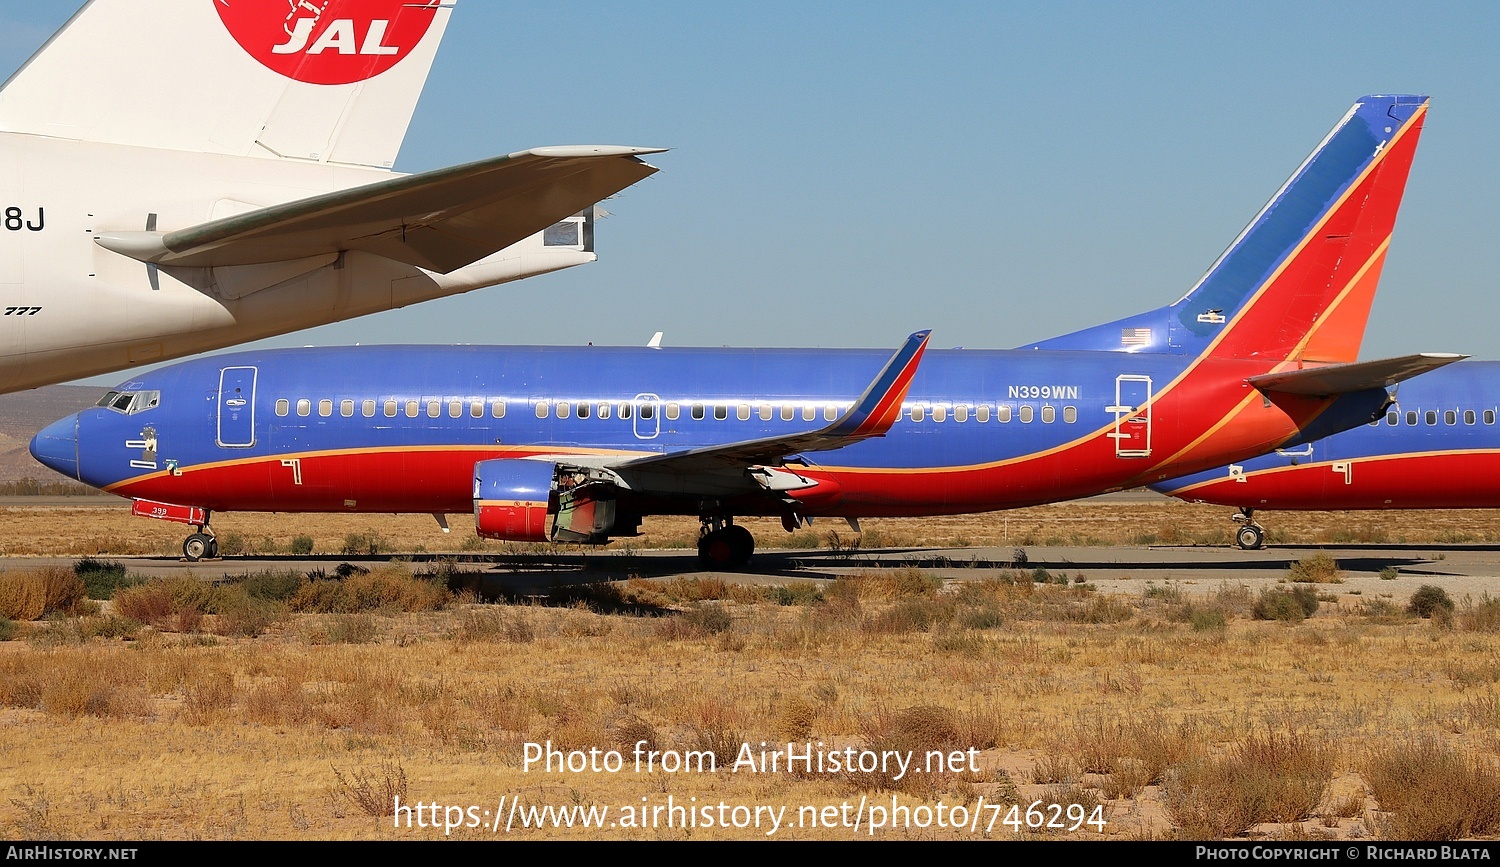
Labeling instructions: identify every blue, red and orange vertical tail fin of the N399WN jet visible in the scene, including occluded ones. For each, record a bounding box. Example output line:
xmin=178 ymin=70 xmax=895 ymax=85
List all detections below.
xmin=1026 ymin=96 xmax=1428 ymax=363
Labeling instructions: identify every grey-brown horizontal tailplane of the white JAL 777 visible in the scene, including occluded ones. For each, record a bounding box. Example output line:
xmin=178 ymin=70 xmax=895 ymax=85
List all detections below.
xmin=89 ymin=146 xmax=665 ymax=273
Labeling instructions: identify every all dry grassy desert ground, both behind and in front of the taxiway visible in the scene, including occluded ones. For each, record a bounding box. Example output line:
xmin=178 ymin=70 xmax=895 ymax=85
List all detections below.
xmin=0 ymin=498 xmax=1500 ymax=840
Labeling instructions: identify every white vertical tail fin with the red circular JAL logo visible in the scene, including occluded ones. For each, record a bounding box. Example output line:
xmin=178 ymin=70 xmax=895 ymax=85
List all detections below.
xmin=0 ymin=0 xmax=453 ymax=168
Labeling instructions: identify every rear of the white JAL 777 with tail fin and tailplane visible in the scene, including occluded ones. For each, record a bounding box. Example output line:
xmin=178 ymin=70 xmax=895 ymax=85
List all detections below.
xmin=0 ymin=0 xmax=656 ymax=393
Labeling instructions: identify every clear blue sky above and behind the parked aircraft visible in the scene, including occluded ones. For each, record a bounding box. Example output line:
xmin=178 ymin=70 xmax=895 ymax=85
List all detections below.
xmin=0 ymin=0 xmax=1500 ymax=372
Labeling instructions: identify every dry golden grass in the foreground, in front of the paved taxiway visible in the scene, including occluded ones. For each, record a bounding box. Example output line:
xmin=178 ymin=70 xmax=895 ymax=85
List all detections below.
xmin=0 ymin=570 xmax=1500 ymax=840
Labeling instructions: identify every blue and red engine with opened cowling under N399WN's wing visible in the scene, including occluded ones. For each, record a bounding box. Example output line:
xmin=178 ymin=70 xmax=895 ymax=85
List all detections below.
xmin=474 ymin=458 xmax=617 ymax=543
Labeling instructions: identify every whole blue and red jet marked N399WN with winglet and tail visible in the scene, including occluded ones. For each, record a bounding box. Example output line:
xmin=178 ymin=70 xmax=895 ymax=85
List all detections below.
xmin=32 ymin=96 xmax=1457 ymax=564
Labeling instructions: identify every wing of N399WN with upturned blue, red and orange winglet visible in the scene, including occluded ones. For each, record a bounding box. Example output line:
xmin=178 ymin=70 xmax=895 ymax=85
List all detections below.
xmin=611 ymin=330 xmax=932 ymax=474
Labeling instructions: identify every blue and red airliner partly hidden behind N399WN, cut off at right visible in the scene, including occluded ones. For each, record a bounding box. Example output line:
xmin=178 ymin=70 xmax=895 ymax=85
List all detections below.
xmin=1154 ymin=362 xmax=1500 ymax=549
